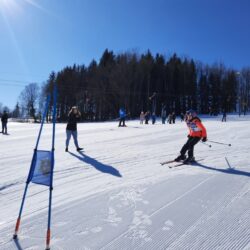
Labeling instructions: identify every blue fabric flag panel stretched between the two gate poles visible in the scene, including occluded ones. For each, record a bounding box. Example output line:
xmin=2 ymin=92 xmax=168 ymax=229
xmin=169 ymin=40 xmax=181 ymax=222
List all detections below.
xmin=30 ymin=150 xmax=52 ymax=186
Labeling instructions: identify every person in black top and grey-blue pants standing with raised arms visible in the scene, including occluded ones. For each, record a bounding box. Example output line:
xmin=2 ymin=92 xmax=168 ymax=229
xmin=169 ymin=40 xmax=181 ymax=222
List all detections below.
xmin=65 ymin=107 xmax=83 ymax=152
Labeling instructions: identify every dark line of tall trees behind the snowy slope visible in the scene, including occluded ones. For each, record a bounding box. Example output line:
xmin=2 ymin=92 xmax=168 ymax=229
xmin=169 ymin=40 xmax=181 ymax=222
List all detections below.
xmin=14 ymin=49 xmax=250 ymax=121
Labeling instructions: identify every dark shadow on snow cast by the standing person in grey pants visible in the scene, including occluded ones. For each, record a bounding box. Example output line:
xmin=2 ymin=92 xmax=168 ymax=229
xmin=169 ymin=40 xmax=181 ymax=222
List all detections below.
xmin=69 ymin=152 xmax=122 ymax=177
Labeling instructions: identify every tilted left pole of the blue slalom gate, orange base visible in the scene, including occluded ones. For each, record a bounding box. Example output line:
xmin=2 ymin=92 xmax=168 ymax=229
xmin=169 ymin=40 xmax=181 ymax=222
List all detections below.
xmin=13 ymin=95 xmax=50 ymax=239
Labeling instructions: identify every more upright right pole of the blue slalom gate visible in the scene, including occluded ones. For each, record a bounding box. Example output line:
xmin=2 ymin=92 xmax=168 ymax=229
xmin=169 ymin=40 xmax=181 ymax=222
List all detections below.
xmin=46 ymin=85 xmax=57 ymax=250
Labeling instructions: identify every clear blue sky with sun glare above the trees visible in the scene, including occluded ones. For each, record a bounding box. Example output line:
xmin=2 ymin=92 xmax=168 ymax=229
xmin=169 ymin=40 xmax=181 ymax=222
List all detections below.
xmin=0 ymin=0 xmax=250 ymax=108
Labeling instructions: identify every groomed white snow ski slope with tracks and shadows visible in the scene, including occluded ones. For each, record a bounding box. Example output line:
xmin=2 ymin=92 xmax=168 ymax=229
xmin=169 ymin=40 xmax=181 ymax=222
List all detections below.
xmin=0 ymin=115 xmax=250 ymax=250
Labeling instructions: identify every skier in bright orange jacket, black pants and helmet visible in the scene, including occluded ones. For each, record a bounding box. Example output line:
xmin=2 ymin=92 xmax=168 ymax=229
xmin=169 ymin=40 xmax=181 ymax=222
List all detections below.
xmin=175 ymin=110 xmax=207 ymax=163
